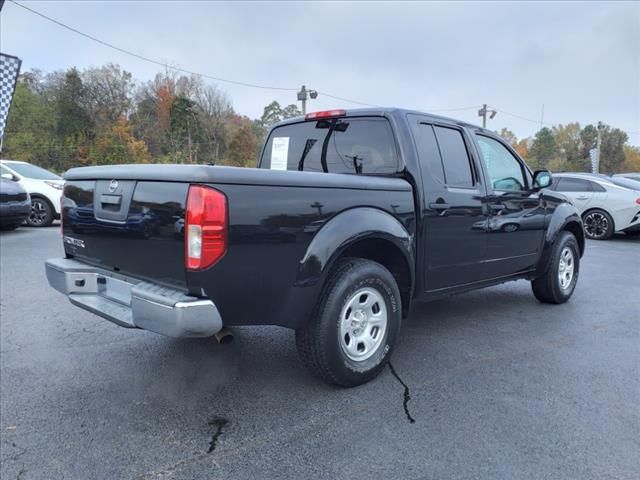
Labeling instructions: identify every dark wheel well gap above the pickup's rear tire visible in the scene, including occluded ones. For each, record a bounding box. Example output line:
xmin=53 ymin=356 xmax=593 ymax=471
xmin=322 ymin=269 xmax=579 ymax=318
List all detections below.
xmin=339 ymin=238 xmax=412 ymax=318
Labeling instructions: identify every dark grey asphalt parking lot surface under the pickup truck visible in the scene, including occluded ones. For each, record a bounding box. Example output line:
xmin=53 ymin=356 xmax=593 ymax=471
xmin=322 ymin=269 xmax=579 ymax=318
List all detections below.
xmin=0 ymin=227 xmax=640 ymax=479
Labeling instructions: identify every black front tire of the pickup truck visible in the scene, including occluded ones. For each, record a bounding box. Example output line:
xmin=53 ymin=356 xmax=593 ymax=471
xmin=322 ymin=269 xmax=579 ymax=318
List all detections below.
xmin=531 ymin=232 xmax=580 ymax=304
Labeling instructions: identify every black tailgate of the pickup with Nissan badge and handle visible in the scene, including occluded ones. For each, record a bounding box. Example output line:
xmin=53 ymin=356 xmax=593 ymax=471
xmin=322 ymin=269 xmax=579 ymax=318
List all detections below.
xmin=62 ymin=179 xmax=189 ymax=289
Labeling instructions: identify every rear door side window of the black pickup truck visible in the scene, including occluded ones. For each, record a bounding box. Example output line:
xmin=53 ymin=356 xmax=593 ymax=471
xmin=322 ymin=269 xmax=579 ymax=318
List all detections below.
xmin=433 ymin=126 xmax=473 ymax=187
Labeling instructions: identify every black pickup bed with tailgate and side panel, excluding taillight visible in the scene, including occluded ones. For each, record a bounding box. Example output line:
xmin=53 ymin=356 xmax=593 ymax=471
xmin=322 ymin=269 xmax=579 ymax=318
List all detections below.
xmin=63 ymin=165 xmax=415 ymax=326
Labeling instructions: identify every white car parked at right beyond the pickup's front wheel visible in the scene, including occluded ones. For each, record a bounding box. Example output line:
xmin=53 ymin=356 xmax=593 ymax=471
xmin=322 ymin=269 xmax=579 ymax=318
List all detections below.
xmin=549 ymin=173 xmax=640 ymax=240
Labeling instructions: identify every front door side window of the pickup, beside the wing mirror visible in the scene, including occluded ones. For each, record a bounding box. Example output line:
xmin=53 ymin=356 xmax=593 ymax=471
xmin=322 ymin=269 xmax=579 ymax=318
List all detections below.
xmin=476 ymin=135 xmax=527 ymax=191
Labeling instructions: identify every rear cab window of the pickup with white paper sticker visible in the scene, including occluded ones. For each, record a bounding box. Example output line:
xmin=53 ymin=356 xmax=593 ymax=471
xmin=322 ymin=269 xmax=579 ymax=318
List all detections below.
xmin=260 ymin=117 xmax=398 ymax=174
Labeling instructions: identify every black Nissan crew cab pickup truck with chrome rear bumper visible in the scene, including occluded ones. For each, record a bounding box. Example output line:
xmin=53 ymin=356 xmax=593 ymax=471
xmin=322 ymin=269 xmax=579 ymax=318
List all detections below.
xmin=46 ymin=109 xmax=585 ymax=386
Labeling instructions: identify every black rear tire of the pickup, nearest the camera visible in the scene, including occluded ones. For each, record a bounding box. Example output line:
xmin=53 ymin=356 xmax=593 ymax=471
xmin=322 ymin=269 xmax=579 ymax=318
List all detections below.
xmin=296 ymin=258 xmax=402 ymax=387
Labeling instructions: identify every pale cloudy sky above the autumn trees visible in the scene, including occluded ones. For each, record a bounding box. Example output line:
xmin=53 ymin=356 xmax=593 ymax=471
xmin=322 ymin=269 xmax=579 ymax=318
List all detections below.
xmin=0 ymin=0 xmax=640 ymax=145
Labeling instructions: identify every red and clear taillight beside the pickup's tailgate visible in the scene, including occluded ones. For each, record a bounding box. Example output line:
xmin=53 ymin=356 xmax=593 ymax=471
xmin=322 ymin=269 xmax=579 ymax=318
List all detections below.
xmin=184 ymin=185 xmax=227 ymax=270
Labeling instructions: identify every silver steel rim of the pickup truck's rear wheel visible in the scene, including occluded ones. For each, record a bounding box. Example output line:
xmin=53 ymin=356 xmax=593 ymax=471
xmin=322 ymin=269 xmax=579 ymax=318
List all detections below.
xmin=340 ymin=288 xmax=387 ymax=362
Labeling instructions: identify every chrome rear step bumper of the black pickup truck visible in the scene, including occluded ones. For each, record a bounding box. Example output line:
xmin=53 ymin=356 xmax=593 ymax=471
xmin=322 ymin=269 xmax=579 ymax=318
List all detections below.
xmin=45 ymin=258 xmax=222 ymax=338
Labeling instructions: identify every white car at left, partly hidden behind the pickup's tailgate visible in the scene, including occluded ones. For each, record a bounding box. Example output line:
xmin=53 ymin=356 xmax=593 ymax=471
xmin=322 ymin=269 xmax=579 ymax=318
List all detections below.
xmin=0 ymin=160 xmax=64 ymax=227
